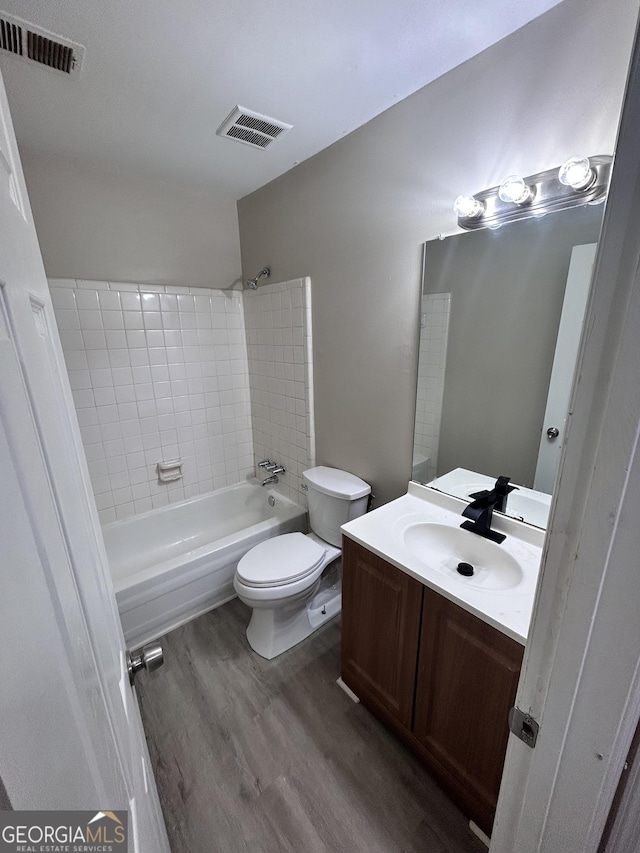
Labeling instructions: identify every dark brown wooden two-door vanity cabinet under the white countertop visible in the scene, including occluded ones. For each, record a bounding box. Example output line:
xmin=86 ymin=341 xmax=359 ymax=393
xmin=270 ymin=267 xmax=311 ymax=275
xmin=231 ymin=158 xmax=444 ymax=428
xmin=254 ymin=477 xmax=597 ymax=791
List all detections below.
xmin=342 ymin=537 xmax=524 ymax=834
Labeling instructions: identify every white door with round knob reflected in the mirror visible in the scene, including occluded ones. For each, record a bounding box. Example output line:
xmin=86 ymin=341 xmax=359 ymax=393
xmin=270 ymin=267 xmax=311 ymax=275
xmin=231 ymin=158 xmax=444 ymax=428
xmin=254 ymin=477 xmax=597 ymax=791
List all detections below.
xmin=533 ymin=243 xmax=597 ymax=495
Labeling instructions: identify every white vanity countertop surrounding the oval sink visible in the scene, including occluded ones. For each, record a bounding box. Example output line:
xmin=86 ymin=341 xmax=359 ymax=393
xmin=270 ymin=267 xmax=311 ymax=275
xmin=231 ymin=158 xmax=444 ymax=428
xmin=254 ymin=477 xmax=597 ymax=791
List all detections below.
xmin=342 ymin=482 xmax=545 ymax=645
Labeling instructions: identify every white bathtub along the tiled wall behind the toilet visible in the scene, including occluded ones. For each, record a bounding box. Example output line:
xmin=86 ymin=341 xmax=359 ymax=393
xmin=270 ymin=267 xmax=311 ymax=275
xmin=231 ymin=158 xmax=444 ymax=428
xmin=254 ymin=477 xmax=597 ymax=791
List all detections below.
xmin=102 ymin=483 xmax=307 ymax=646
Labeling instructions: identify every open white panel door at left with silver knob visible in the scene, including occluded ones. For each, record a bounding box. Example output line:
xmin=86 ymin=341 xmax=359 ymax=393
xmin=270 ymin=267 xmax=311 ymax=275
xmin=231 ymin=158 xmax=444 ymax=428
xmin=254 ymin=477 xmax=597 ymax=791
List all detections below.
xmin=0 ymin=68 xmax=169 ymax=853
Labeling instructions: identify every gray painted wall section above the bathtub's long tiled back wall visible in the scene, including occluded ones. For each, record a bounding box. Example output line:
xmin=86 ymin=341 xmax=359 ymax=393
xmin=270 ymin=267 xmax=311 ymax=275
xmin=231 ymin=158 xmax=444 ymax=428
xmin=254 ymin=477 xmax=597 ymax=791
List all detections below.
xmin=20 ymin=148 xmax=240 ymax=288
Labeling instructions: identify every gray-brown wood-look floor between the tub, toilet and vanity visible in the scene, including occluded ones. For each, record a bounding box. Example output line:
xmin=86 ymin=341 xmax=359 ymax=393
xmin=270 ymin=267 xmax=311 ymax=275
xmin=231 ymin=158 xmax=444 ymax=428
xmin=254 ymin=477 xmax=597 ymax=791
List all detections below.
xmin=136 ymin=599 xmax=486 ymax=853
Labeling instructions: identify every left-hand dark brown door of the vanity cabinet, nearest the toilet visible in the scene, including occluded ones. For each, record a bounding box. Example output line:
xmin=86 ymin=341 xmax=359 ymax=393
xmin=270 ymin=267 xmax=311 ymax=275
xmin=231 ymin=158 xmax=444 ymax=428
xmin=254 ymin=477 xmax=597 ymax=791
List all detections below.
xmin=342 ymin=537 xmax=423 ymax=729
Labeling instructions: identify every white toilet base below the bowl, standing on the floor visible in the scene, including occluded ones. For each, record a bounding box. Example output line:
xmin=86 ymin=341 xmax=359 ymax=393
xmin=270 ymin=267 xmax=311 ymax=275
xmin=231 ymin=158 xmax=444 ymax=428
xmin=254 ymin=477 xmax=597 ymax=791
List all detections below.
xmin=247 ymin=570 xmax=342 ymax=660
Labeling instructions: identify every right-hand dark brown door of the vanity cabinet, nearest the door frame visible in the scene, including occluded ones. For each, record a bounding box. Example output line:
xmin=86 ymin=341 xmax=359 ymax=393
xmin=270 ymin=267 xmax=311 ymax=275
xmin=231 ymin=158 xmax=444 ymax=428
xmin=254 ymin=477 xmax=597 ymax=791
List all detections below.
xmin=414 ymin=589 xmax=524 ymax=833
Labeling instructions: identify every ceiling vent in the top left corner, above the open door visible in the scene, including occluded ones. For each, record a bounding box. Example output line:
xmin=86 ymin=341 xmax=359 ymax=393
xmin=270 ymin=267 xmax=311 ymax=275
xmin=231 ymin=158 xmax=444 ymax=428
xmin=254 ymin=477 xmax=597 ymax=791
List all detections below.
xmin=0 ymin=12 xmax=84 ymax=77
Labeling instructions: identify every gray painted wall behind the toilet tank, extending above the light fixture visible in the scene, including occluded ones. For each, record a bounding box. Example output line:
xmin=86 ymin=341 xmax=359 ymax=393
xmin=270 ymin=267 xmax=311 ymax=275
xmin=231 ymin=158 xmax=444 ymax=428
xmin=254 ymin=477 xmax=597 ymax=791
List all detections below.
xmin=238 ymin=0 xmax=638 ymax=502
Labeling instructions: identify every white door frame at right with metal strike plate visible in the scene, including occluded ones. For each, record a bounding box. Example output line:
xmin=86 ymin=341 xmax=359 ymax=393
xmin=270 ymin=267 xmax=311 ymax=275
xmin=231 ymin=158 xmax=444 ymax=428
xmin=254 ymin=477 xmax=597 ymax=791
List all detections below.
xmin=490 ymin=13 xmax=640 ymax=853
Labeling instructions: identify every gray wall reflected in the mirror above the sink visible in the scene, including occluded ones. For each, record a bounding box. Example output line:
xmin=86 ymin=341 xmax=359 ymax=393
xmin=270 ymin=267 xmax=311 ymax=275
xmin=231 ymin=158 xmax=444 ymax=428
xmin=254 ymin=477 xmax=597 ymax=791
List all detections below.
xmin=424 ymin=205 xmax=604 ymax=486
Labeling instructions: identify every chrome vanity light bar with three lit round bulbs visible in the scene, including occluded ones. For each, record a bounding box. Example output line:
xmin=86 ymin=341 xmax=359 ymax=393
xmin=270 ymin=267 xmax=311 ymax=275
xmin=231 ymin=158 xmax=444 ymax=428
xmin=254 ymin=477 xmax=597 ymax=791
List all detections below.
xmin=454 ymin=155 xmax=613 ymax=231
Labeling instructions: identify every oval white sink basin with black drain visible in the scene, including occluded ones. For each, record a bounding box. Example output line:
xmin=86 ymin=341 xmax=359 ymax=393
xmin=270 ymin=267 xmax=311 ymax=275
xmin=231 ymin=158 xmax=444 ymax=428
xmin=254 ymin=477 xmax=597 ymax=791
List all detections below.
xmin=403 ymin=522 xmax=524 ymax=591
